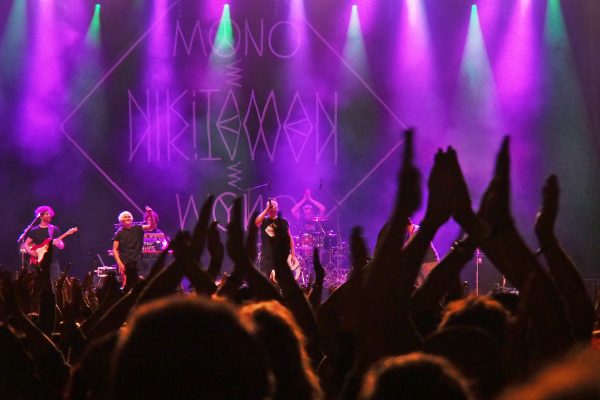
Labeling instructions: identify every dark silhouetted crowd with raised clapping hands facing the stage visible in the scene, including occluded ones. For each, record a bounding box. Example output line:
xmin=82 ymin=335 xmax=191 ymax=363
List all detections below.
xmin=0 ymin=131 xmax=600 ymax=400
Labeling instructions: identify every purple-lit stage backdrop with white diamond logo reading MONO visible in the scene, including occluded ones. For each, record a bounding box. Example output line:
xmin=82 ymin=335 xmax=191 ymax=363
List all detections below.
xmin=0 ymin=0 xmax=600 ymax=282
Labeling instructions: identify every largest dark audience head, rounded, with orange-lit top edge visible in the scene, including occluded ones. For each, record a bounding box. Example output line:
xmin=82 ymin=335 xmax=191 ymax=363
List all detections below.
xmin=112 ymin=296 xmax=270 ymax=399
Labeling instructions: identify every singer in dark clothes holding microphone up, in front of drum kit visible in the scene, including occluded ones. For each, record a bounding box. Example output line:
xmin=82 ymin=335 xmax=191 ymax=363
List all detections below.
xmin=254 ymin=199 xmax=296 ymax=277
